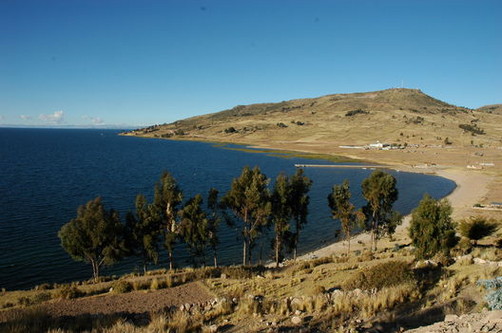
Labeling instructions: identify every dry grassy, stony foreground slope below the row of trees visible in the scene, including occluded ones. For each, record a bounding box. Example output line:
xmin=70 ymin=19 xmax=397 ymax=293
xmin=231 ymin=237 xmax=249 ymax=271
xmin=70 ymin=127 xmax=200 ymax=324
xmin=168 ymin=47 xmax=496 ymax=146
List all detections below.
xmin=0 ymin=224 xmax=502 ymax=332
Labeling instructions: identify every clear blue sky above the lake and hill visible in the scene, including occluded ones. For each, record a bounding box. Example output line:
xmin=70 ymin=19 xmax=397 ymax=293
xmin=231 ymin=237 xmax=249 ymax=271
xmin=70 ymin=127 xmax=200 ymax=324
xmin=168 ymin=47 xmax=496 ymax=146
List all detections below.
xmin=0 ymin=0 xmax=502 ymax=126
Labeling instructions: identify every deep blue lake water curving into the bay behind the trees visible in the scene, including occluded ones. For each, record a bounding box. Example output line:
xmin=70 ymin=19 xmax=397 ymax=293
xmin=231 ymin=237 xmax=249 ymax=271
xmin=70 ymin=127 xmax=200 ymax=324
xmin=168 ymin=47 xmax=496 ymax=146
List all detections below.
xmin=0 ymin=128 xmax=455 ymax=289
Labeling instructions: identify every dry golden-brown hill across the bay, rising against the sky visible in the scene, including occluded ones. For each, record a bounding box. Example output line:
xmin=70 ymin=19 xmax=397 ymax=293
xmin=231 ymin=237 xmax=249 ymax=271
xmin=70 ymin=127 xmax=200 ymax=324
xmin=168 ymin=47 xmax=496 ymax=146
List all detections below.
xmin=124 ymin=89 xmax=502 ymax=146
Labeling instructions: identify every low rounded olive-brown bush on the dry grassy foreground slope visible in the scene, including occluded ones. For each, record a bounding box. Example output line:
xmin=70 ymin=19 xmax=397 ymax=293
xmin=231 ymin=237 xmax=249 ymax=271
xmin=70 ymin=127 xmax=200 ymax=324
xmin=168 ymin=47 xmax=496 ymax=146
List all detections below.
xmin=343 ymin=260 xmax=413 ymax=290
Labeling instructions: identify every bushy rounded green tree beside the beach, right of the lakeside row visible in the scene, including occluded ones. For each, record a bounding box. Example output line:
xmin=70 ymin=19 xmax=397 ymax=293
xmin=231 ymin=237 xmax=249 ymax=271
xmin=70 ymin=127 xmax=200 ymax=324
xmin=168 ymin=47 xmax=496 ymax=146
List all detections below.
xmin=408 ymin=194 xmax=458 ymax=259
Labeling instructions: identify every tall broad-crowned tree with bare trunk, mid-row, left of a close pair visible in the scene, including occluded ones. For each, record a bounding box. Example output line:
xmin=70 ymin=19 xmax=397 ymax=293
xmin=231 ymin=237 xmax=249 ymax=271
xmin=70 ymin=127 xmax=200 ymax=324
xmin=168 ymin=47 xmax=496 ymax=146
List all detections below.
xmin=222 ymin=166 xmax=271 ymax=265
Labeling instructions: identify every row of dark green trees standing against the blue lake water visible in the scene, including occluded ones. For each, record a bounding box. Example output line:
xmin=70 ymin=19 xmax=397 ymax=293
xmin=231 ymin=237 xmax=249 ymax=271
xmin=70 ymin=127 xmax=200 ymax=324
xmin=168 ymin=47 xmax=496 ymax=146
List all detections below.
xmin=58 ymin=167 xmax=410 ymax=278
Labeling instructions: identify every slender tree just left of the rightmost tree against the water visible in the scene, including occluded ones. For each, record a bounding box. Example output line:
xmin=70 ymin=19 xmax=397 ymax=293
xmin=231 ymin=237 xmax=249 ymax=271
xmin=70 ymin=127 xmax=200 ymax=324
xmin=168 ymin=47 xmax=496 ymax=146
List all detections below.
xmin=328 ymin=180 xmax=364 ymax=255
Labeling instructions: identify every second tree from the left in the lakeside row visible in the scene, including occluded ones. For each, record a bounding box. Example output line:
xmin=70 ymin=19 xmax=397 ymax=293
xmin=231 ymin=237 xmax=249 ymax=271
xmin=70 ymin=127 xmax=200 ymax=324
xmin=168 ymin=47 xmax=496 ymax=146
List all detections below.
xmin=126 ymin=194 xmax=161 ymax=273
